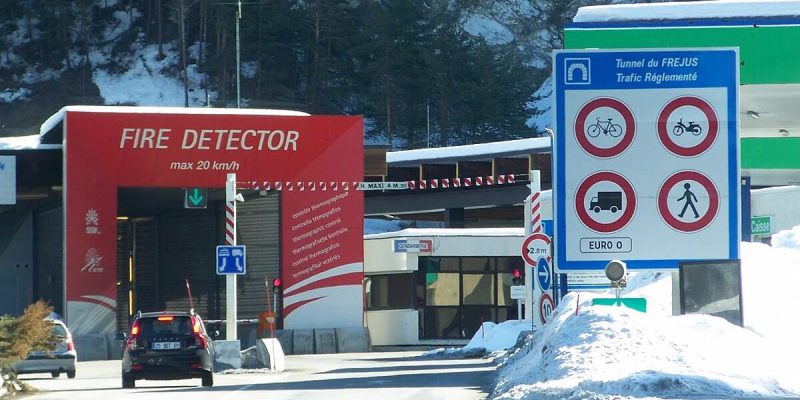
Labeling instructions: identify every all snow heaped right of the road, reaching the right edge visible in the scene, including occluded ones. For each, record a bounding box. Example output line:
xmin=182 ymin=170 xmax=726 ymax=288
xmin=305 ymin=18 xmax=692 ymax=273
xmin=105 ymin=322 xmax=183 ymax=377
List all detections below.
xmin=454 ymin=234 xmax=800 ymax=400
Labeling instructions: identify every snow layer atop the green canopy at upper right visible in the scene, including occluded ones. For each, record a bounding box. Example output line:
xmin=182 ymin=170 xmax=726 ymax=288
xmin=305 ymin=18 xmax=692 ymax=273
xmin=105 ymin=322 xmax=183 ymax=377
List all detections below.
xmin=573 ymin=0 xmax=800 ymax=23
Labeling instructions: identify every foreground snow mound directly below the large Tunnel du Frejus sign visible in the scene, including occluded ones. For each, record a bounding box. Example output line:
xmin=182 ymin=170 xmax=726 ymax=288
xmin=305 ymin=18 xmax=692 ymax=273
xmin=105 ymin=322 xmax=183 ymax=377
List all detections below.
xmin=497 ymin=293 xmax=792 ymax=399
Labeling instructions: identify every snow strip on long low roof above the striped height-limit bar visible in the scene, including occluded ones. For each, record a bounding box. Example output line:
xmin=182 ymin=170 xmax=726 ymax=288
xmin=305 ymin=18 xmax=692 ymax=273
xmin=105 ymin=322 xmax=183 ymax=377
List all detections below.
xmin=386 ymin=137 xmax=550 ymax=167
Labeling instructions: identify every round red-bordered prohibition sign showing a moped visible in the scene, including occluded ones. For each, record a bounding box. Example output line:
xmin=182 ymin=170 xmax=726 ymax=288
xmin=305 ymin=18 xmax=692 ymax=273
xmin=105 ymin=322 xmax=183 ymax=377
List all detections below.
xmin=656 ymin=96 xmax=719 ymax=157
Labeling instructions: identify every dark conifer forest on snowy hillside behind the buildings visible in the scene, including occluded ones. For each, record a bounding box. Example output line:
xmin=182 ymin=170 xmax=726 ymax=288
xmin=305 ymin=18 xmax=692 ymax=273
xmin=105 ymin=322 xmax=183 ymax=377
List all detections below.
xmin=0 ymin=0 xmax=628 ymax=148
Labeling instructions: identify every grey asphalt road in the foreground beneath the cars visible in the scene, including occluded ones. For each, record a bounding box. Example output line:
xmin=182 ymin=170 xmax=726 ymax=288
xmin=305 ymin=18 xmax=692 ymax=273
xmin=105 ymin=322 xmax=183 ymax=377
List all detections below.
xmin=22 ymin=352 xmax=494 ymax=400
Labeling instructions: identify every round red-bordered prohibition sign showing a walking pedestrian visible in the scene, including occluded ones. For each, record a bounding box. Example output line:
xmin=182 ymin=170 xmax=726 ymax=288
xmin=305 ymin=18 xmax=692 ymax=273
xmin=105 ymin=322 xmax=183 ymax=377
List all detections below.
xmin=658 ymin=171 xmax=719 ymax=233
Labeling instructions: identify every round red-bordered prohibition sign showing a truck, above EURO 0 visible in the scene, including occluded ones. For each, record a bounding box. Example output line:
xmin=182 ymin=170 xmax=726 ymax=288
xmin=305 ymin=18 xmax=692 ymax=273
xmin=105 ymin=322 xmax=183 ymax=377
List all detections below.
xmin=575 ymin=171 xmax=636 ymax=233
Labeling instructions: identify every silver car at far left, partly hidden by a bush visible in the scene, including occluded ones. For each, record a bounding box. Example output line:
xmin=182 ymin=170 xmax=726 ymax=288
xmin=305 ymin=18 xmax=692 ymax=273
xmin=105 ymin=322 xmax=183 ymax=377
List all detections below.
xmin=14 ymin=318 xmax=78 ymax=379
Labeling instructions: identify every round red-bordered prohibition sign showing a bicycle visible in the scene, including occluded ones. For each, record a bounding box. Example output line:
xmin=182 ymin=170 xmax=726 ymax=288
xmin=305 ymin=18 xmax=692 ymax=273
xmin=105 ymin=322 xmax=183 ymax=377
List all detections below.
xmin=575 ymin=97 xmax=636 ymax=158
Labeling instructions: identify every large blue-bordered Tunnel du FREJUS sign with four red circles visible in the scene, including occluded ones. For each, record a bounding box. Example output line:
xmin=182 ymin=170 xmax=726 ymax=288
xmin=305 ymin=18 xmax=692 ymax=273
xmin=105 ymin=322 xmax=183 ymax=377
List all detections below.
xmin=553 ymin=48 xmax=741 ymax=272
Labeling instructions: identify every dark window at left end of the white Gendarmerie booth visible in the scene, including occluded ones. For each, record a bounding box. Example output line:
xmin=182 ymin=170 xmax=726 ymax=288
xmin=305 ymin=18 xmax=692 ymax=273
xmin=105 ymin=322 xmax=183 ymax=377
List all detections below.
xmin=364 ymin=273 xmax=416 ymax=311
